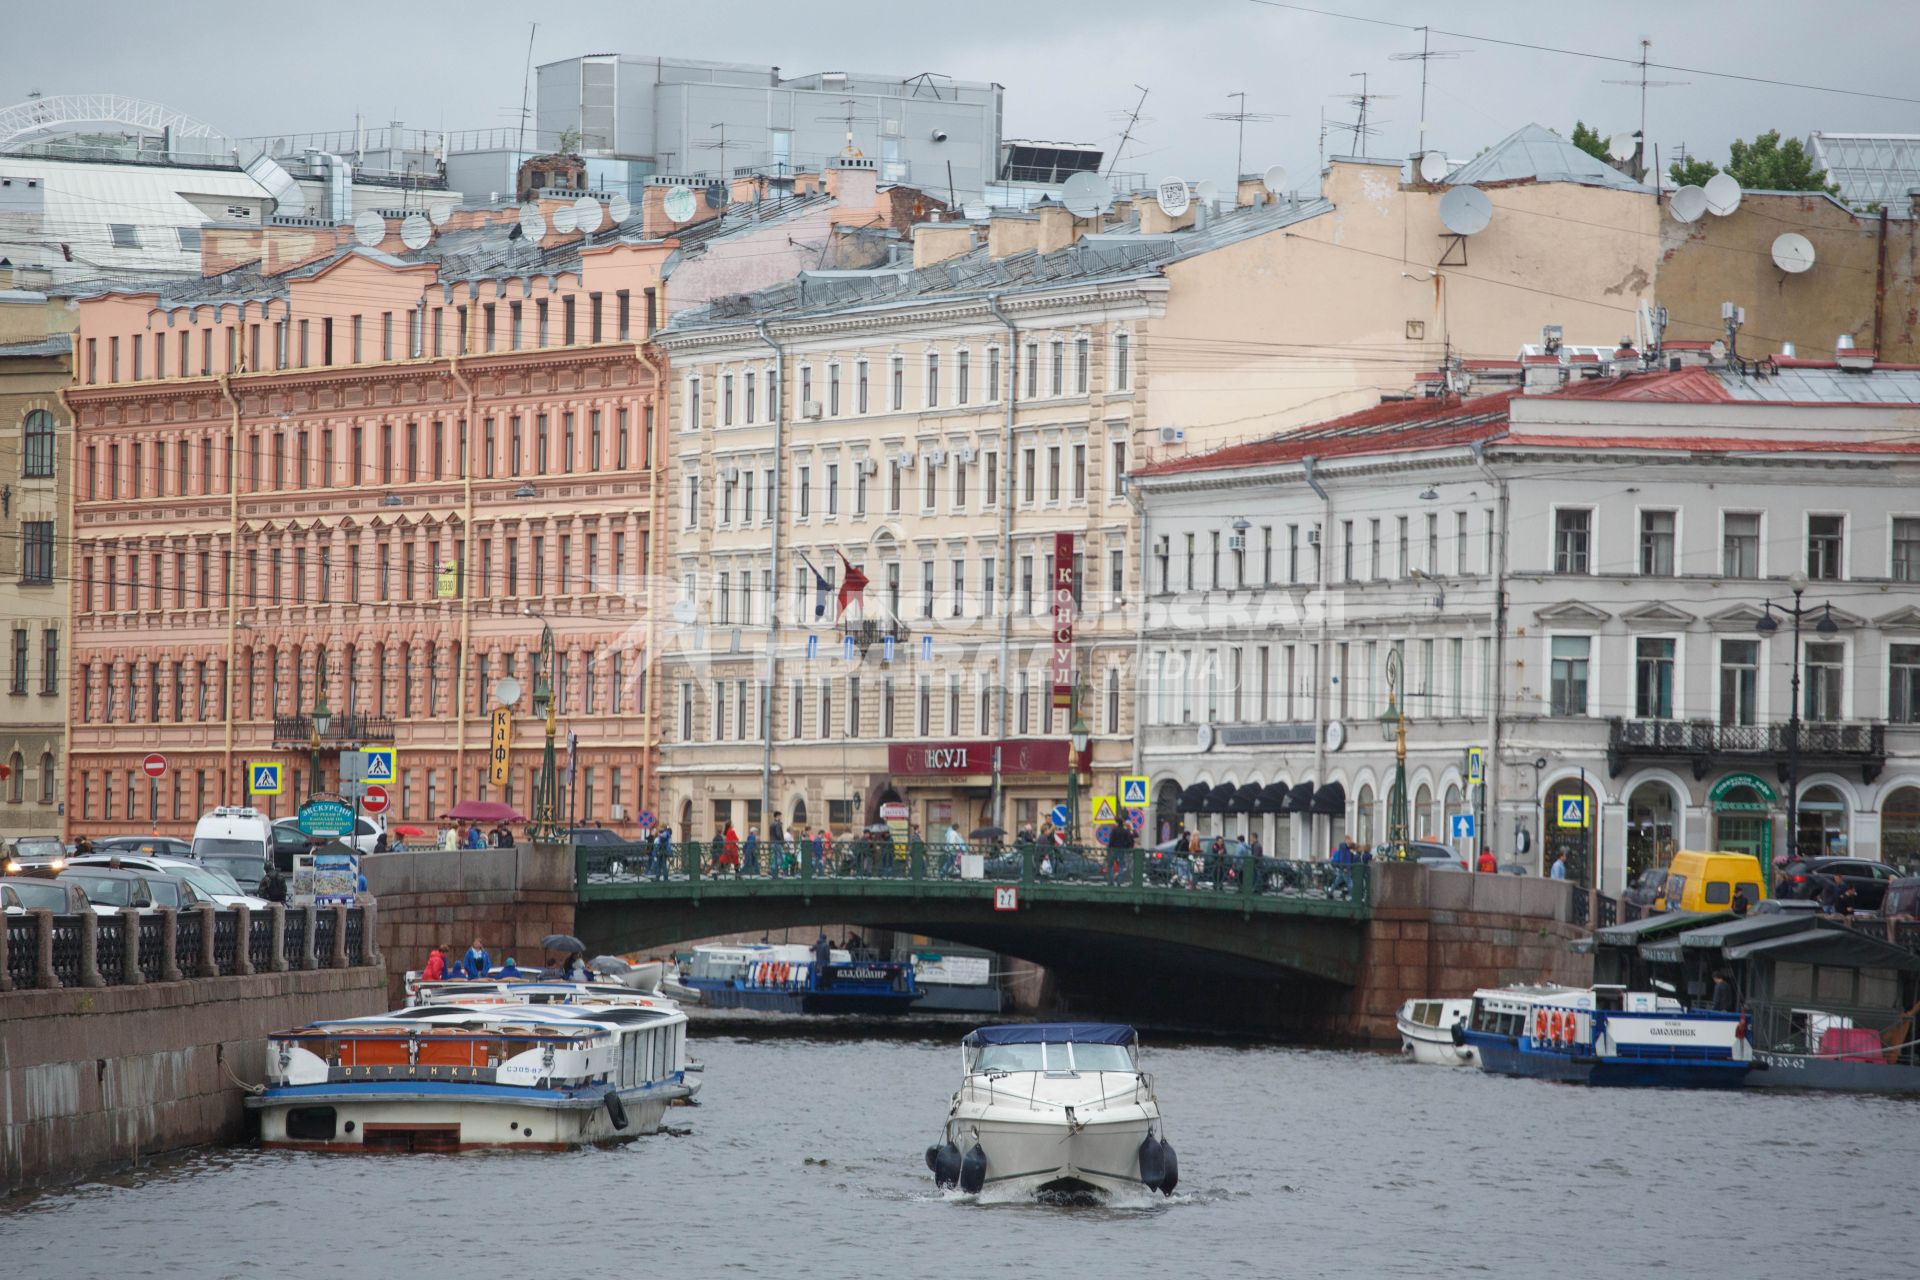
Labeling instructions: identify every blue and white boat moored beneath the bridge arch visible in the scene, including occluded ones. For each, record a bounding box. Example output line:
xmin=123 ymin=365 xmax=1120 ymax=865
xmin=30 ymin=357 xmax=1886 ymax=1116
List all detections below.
xmin=680 ymin=942 xmax=922 ymax=1015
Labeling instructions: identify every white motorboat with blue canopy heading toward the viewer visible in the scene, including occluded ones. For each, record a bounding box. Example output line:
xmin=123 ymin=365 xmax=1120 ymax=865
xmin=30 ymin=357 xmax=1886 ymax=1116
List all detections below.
xmin=927 ymin=1023 xmax=1179 ymax=1199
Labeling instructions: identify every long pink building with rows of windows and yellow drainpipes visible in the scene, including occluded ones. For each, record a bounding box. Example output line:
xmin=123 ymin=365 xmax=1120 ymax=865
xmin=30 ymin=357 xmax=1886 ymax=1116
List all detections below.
xmin=67 ymin=200 xmax=674 ymax=835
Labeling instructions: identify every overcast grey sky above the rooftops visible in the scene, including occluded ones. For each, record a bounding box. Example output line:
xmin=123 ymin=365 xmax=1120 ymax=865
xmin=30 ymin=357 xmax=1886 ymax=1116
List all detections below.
xmin=0 ymin=0 xmax=1920 ymax=184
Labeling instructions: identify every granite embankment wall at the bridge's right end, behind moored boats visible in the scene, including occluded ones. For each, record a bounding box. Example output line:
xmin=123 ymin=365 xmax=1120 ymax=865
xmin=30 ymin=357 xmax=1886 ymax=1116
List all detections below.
xmin=1334 ymin=864 xmax=1594 ymax=1042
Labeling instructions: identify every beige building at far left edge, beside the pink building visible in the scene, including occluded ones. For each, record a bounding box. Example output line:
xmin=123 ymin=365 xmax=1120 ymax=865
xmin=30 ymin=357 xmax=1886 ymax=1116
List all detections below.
xmin=0 ymin=278 xmax=73 ymax=841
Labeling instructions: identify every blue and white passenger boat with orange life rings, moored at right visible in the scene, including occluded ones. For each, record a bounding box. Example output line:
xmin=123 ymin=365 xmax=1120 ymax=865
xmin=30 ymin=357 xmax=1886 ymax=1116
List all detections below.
xmin=1453 ymin=986 xmax=1753 ymax=1088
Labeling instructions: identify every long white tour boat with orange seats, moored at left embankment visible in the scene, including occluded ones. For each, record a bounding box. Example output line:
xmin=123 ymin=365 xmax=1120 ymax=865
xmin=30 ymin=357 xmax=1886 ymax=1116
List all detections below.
xmin=246 ymin=1000 xmax=695 ymax=1151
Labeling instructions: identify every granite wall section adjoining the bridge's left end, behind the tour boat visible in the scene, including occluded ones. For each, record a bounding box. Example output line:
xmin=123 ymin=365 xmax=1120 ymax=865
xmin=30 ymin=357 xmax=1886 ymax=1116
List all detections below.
xmin=361 ymin=844 xmax=574 ymax=1006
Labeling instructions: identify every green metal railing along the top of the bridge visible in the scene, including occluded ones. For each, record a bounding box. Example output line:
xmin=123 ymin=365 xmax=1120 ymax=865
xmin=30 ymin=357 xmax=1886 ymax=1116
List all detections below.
xmin=576 ymin=841 xmax=1369 ymax=904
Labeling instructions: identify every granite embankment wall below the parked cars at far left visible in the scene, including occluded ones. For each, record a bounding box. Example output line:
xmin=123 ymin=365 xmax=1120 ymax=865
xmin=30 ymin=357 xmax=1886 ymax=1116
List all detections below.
xmin=0 ymin=965 xmax=388 ymax=1192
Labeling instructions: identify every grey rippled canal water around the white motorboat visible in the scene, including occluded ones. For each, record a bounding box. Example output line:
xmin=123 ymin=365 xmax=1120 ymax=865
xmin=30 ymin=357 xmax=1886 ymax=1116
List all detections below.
xmin=0 ymin=1029 xmax=1920 ymax=1280
